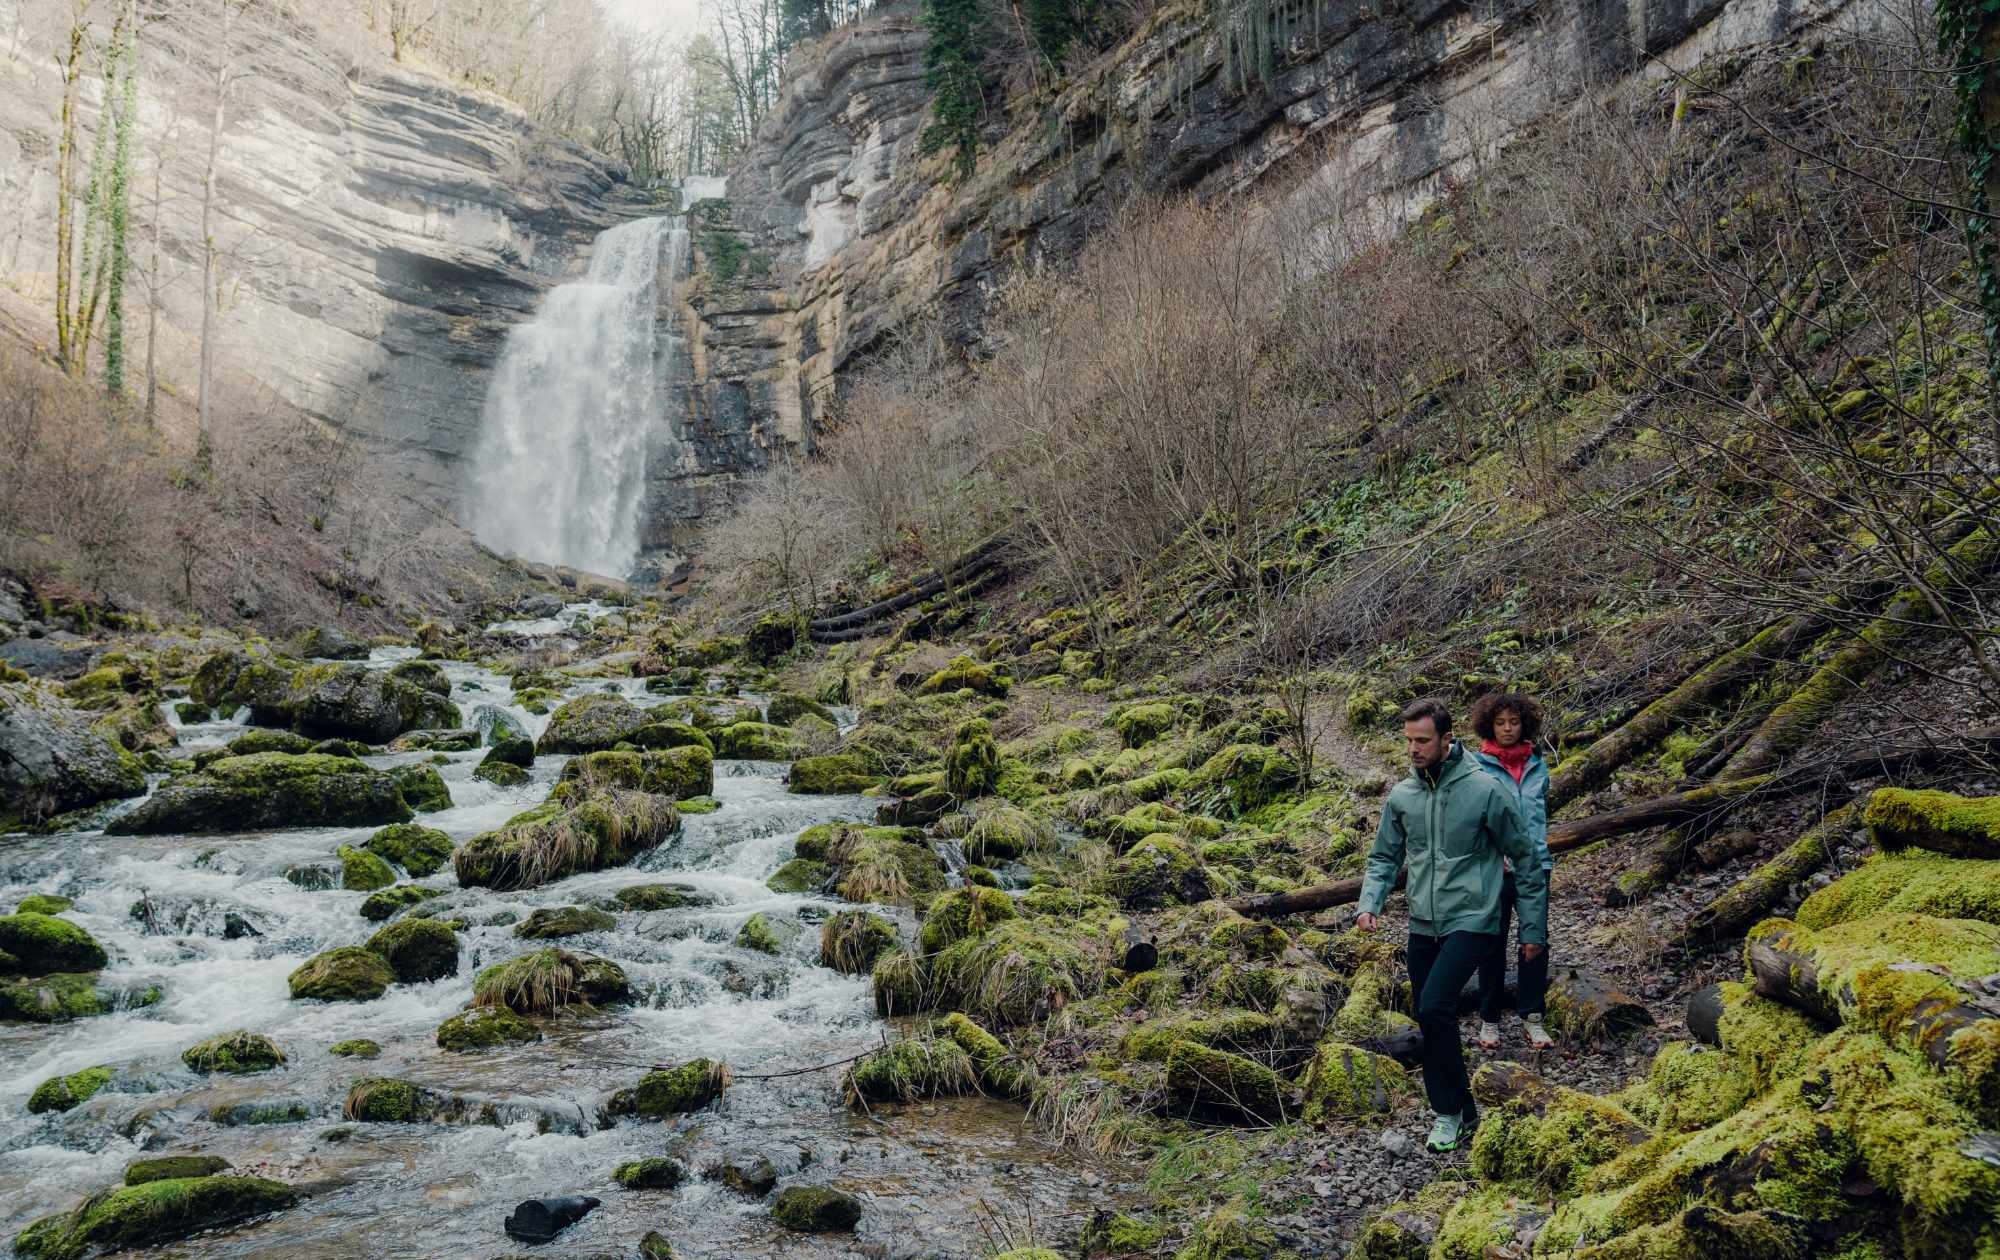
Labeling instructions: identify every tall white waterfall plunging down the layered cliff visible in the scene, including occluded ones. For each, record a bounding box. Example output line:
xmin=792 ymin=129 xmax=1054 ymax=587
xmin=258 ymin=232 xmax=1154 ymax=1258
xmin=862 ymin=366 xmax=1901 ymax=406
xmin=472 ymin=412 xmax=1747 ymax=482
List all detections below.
xmin=466 ymin=218 xmax=688 ymax=578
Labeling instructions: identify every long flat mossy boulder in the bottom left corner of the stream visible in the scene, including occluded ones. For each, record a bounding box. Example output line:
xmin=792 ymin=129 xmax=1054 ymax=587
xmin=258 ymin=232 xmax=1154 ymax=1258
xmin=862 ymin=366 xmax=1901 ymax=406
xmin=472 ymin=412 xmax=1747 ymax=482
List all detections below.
xmin=14 ymin=1176 xmax=298 ymax=1260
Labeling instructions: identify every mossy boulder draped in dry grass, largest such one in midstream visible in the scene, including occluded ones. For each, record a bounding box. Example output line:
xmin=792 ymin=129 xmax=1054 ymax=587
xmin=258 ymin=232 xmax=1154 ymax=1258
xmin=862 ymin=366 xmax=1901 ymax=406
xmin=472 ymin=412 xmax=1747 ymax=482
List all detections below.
xmin=452 ymin=784 xmax=680 ymax=890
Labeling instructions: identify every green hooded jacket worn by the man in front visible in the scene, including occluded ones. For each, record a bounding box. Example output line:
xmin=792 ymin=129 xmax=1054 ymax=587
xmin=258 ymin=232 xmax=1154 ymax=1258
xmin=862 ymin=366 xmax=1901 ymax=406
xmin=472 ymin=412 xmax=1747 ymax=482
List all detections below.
xmin=1360 ymin=740 xmax=1548 ymax=944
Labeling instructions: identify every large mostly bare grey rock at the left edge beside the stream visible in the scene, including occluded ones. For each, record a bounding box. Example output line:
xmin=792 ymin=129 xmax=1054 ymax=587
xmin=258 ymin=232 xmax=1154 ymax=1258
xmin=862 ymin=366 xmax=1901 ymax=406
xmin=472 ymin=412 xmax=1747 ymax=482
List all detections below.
xmin=0 ymin=682 xmax=146 ymax=830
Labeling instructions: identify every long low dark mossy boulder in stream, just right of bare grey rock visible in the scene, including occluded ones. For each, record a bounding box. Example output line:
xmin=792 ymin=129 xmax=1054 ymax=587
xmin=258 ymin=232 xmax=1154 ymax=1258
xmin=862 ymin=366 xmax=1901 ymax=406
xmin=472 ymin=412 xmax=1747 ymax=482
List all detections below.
xmin=106 ymin=752 xmax=412 ymax=836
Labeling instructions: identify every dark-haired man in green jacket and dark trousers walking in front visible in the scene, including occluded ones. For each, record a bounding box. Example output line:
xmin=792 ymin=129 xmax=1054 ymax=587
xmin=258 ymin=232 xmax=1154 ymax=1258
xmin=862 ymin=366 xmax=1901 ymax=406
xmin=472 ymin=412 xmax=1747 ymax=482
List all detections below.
xmin=1354 ymin=700 xmax=1548 ymax=1152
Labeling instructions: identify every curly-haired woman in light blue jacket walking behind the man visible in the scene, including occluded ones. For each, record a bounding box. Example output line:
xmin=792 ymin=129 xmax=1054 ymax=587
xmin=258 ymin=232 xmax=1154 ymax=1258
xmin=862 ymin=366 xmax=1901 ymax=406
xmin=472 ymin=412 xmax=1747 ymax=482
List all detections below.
xmin=1472 ymin=692 xmax=1556 ymax=1050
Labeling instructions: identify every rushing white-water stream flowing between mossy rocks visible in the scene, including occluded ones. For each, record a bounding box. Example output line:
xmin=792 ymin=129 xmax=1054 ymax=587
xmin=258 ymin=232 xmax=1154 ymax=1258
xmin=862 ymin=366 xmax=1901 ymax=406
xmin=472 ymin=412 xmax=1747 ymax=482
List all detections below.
xmin=0 ymin=608 xmax=1102 ymax=1260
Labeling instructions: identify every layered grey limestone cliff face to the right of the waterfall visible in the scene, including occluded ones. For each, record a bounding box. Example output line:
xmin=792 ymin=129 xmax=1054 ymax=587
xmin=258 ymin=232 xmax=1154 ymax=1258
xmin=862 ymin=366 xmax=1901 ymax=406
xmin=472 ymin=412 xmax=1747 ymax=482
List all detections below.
xmin=684 ymin=0 xmax=1886 ymax=498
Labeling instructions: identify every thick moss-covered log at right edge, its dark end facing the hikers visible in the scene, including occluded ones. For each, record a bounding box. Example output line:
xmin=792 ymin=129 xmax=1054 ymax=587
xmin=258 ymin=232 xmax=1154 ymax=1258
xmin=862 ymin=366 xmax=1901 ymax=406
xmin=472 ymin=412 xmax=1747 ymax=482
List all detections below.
xmin=1744 ymin=914 xmax=2000 ymax=1124
